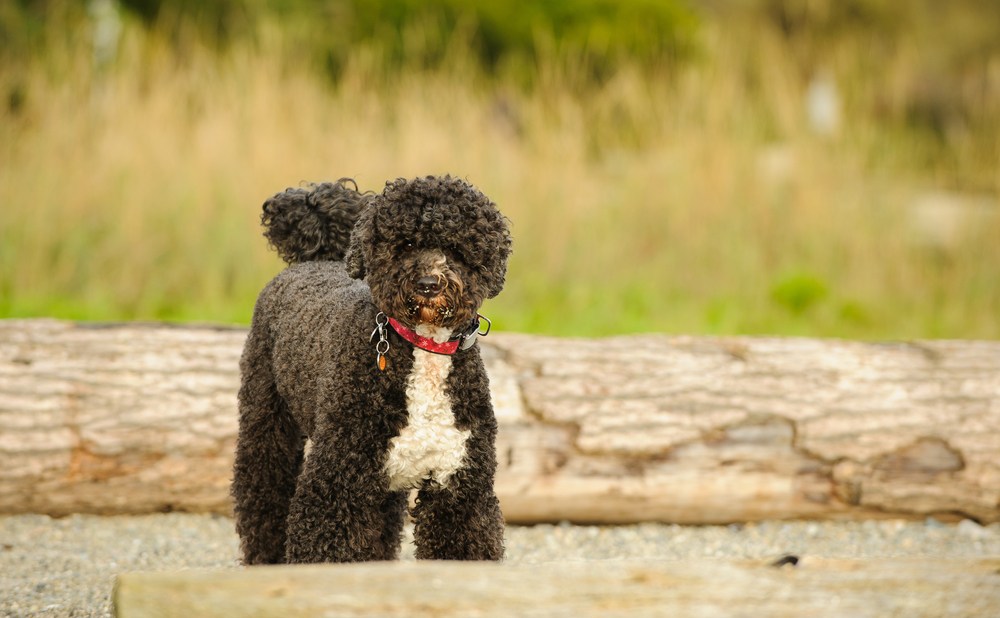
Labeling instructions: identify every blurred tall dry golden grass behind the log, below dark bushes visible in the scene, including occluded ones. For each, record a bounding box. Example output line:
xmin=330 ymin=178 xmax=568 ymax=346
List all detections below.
xmin=0 ymin=18 xmax=1000 ymax=338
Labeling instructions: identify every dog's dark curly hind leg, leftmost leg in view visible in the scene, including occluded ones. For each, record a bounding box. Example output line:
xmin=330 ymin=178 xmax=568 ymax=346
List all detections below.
xmin=232 ymin=325 xmax=305 ymax=565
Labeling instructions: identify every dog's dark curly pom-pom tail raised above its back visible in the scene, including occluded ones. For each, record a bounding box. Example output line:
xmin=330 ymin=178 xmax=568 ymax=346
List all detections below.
xmin=260 ymin=178 xmax=367 ymax=264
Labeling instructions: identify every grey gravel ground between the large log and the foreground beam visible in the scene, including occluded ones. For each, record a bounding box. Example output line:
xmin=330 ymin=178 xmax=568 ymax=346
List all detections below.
xmin=0 ymin=514 xmax=1000 ymax=617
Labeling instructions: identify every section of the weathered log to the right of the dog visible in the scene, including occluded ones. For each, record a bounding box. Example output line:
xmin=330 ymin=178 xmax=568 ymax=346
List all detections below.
xmin=493 ymin=335 xmax=1000 ymax=523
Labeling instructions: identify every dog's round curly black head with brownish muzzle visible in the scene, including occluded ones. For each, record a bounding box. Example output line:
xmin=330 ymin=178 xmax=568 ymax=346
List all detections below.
xmin=346 ymin=176 xmax=511 ymax=330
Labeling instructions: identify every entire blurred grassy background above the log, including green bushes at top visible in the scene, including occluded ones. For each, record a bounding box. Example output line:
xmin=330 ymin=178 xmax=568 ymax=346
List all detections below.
xmin=0 ymin=0 xmax=1000 ymax=339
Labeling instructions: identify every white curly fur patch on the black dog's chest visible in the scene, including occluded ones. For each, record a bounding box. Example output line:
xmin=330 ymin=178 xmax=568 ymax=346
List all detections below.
xmin=385 ymin=327 xmax=471 ymax=491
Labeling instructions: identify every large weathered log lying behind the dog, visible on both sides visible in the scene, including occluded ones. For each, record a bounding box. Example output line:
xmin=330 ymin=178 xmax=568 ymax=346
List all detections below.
xmin=0 ymin=320 xmax=1000 ymax=523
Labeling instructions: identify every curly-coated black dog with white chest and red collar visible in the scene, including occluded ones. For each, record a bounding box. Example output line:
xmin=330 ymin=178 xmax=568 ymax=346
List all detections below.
xmin=232 ymin=176 xmax=511 ymax=564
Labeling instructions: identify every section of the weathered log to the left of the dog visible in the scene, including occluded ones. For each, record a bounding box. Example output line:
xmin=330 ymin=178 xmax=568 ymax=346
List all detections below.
xmin=0 ymin=320 xmax=246 ymax=515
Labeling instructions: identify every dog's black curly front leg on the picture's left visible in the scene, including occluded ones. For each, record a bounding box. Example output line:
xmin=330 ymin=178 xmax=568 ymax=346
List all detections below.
xmin=286 ymin=434 xmax=406 ymax=563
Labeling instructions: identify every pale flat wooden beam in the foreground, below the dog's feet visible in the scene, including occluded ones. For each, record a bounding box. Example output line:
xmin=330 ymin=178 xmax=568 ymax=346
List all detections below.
xmin=114 ymin=558 xmax=1000 ymax=618
